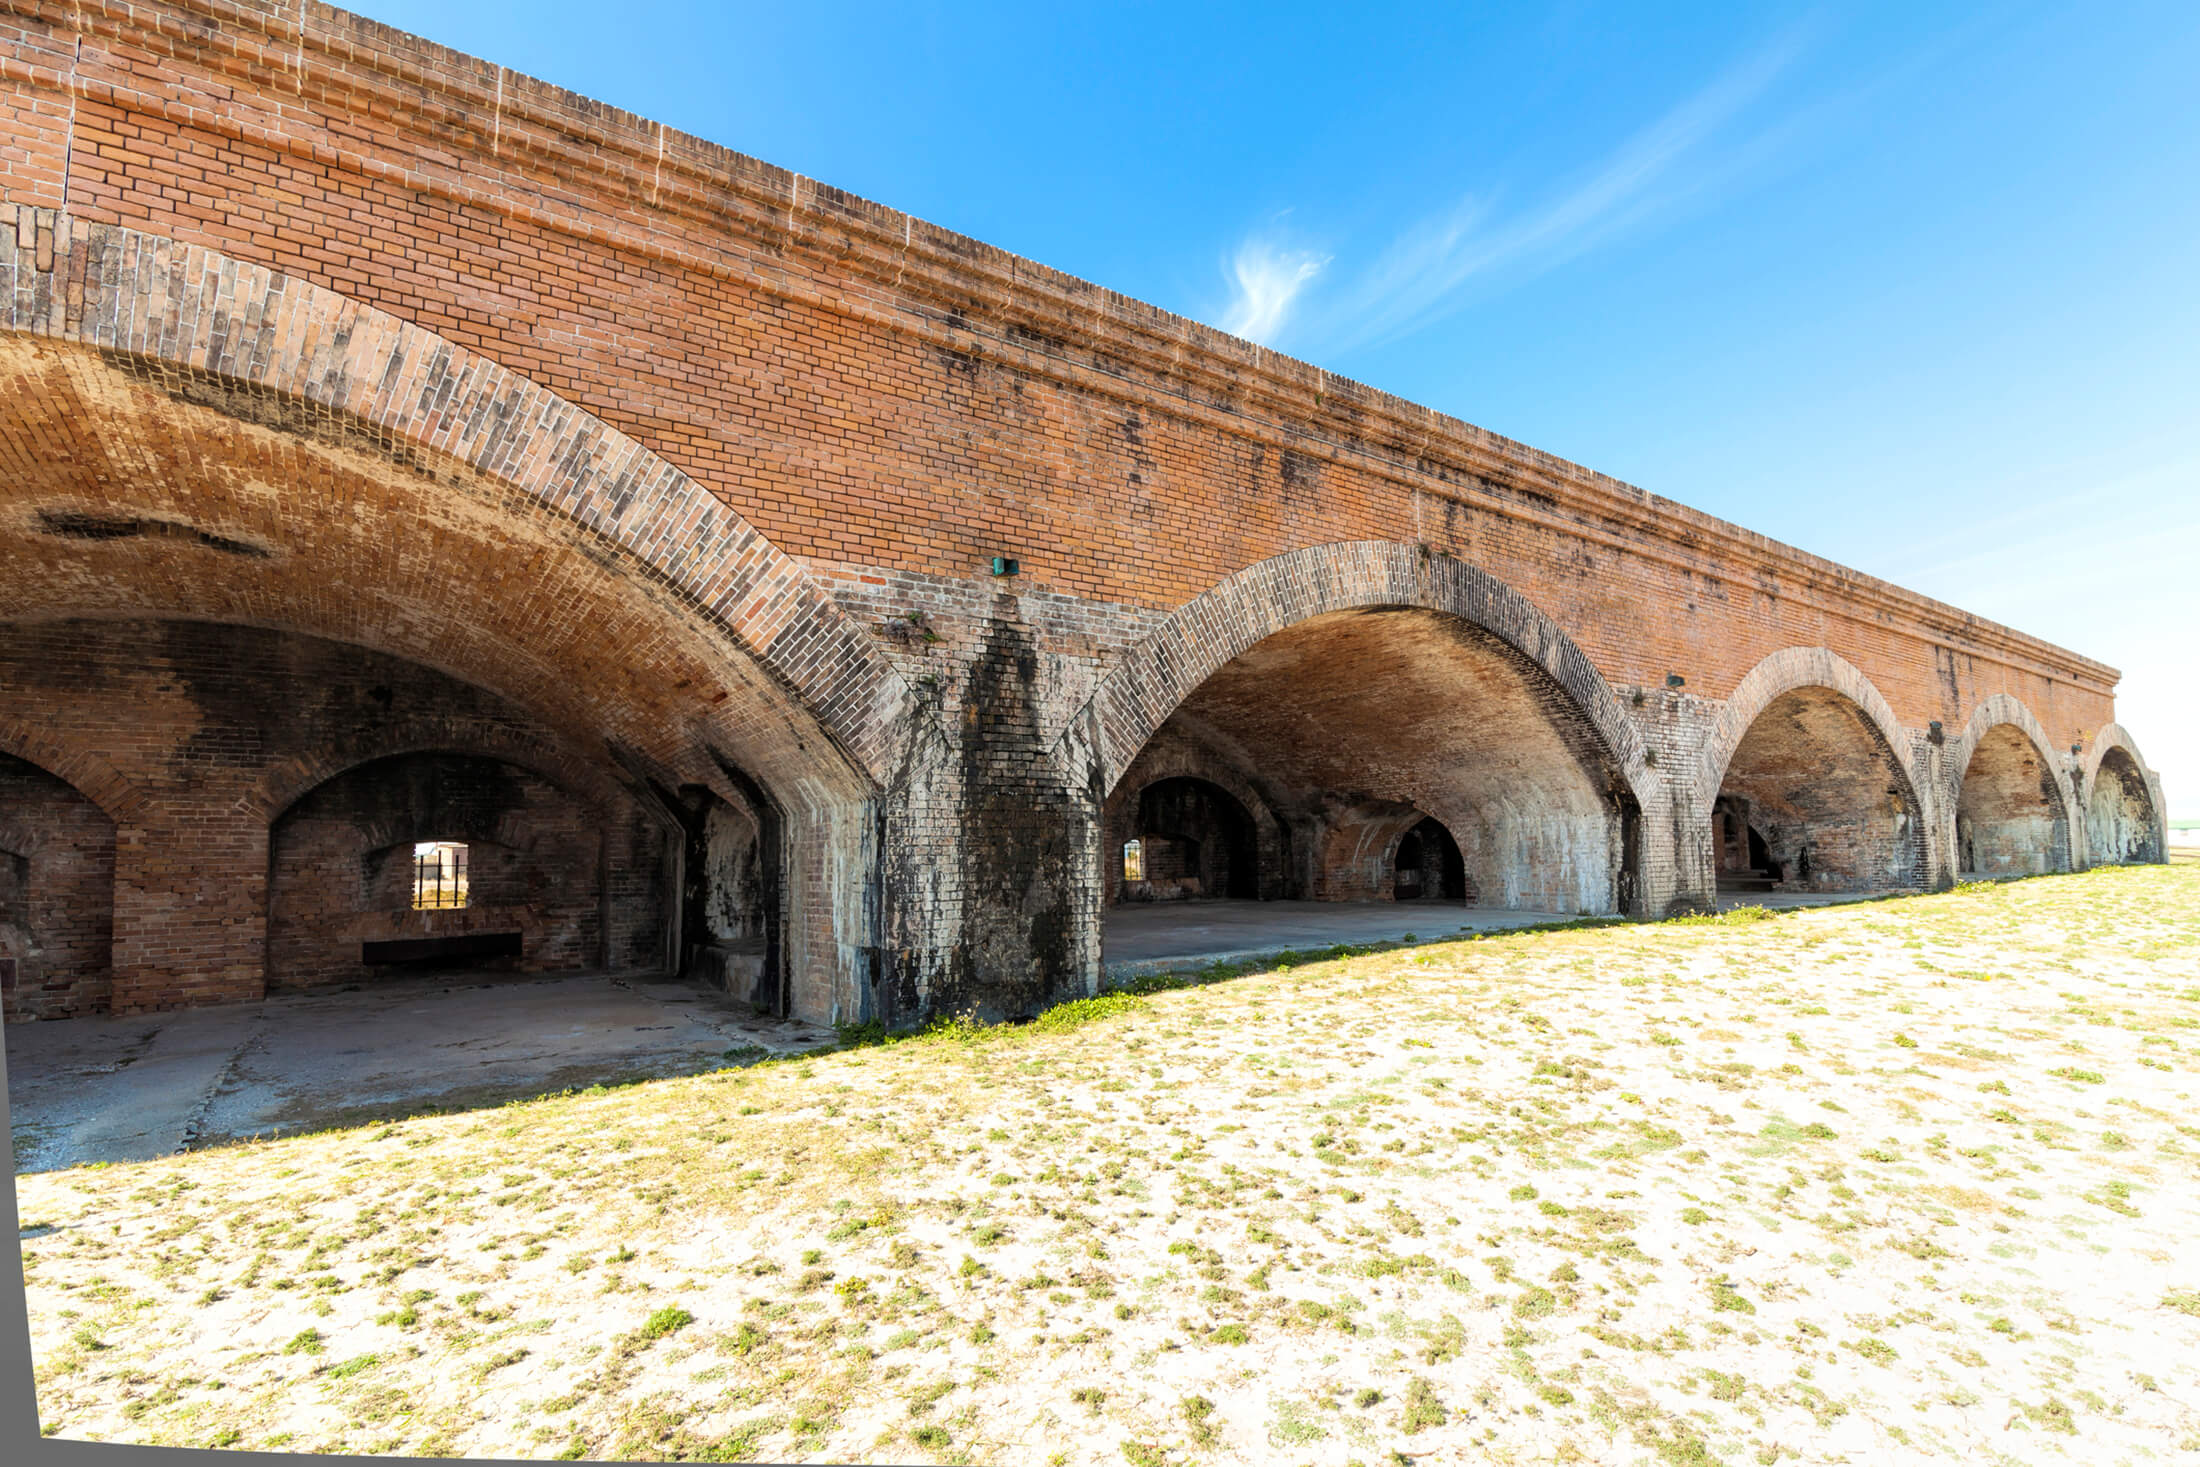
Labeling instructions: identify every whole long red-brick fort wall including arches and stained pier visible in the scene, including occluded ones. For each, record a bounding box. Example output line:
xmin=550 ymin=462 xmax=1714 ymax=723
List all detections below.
xmin=0 ymin=0 xmax=2160 ymax=1021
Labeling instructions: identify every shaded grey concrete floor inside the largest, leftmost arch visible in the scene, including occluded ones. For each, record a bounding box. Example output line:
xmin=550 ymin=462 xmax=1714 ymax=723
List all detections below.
xmin=7 ymin=974 xmax=834 ymax=1172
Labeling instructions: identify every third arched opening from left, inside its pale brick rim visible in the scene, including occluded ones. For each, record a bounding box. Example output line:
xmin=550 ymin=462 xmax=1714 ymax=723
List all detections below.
xmin=1712 ymin=686 xmax=1925 ymax=893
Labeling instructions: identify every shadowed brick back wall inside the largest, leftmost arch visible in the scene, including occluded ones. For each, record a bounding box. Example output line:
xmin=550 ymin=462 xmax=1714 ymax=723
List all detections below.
xmin=0 ymin=620 xmax=667 ymax=1012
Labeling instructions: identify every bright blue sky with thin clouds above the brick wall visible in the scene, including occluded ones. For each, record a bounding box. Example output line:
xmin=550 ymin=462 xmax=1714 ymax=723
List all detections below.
xmin=361 ymin=0 xmax=2200 ymax=816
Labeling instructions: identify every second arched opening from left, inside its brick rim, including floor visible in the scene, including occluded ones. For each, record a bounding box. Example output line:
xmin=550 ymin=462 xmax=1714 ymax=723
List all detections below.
xmin=1107 ymin=589 xmax=1639 ymax=968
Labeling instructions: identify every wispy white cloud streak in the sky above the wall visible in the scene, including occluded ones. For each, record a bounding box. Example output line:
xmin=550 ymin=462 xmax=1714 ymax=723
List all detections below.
xmin=1217 ymin=31 xmax=1802 ymax=354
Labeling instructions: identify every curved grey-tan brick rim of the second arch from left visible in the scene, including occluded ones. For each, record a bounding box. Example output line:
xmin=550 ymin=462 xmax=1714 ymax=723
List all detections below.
xmin=1093 ymin=541 xmax=1663 ymax=796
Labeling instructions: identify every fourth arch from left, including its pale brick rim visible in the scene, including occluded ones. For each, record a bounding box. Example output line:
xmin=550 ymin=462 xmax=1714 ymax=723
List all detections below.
xmin=1940 ymin=693 xmax=2079 ymax=875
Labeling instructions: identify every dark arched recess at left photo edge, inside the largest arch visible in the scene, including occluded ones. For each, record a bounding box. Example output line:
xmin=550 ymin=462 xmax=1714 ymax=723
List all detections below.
xmin=0 ymin=754 xmax=114 ymax=1021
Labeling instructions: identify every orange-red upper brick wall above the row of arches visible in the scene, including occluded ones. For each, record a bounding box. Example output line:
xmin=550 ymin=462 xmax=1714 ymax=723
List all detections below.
xmin=11 ymin=0 xmax=2108 ymax=730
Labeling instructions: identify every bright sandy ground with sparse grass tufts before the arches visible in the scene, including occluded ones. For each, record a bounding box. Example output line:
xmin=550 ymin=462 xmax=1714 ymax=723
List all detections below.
xmin=18 ymin=860 xmax=2200 ymax=1467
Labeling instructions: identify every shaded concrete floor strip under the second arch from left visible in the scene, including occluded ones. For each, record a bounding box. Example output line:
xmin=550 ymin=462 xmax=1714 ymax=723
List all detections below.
xmin=1100 ymin=902 xmax=1573 ymax=981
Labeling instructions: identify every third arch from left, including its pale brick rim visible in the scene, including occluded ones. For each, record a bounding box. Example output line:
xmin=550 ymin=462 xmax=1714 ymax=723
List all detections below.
xmin=1696 ymin=647 xmax=1934 ymax=891
